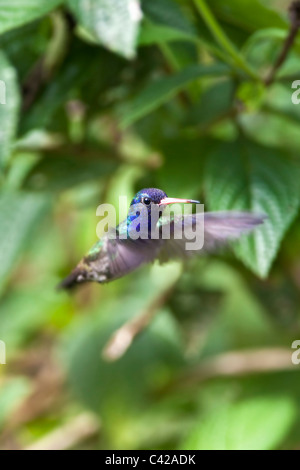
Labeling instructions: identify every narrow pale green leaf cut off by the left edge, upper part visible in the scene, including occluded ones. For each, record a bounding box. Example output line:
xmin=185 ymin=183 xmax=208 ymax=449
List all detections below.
xmin=0 ymin=51 xmax=20 ymax=169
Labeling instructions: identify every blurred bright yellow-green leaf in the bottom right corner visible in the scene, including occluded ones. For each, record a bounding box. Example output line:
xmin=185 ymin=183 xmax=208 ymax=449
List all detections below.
xmin=180 ymin=396 xmax=296 ymax=450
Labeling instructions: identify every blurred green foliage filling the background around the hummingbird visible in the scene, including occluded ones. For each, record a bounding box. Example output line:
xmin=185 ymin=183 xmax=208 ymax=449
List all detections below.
xmin=0 ymin=0 xmax=300 ymax=449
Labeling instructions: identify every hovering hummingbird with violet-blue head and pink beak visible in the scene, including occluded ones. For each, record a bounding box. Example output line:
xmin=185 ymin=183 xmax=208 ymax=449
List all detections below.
xmin=58 ymin=188 xmax=266 ymax=289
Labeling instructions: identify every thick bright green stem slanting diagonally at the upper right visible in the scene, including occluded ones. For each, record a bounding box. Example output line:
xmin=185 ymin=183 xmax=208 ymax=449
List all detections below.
xmin=194 ymin=0 xmax=260 ymax=80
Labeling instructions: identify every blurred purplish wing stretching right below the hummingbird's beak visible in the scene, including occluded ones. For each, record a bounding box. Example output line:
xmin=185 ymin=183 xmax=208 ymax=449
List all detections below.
xmin=159 ymin=211 xmax=267 ymax=262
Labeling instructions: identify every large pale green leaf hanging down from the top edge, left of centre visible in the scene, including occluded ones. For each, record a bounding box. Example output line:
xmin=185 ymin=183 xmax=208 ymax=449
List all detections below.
xmin=68 ymin=0 xmax=142 ymax=59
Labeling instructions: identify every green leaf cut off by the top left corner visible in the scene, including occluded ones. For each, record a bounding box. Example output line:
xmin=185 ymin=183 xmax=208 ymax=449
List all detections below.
xmin=0 ymin=0 xmax=64 ymax=34
